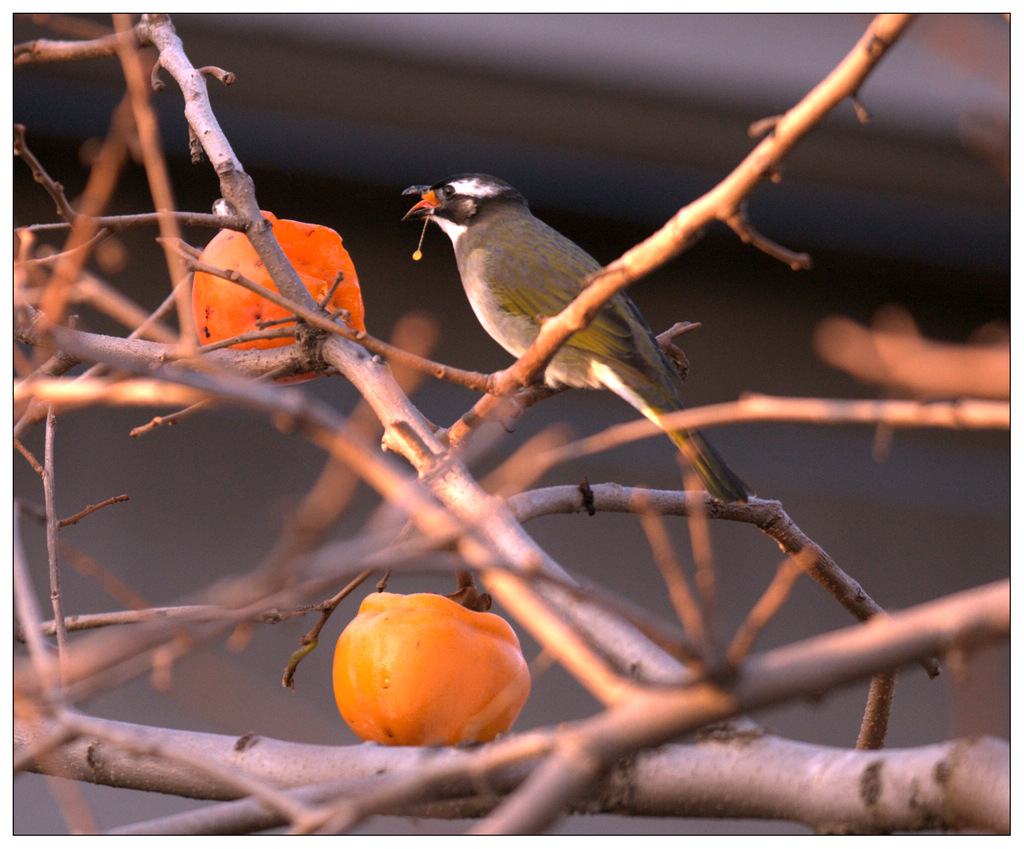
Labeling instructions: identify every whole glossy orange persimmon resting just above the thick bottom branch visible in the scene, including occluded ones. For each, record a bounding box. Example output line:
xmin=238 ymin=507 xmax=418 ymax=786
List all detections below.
xmin=334 ymin=593 xmax=529 ymax=746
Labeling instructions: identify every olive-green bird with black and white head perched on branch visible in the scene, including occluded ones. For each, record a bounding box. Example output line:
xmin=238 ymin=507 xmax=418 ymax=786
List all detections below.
xmin=402 ymin=174 xmax=752 ymax=502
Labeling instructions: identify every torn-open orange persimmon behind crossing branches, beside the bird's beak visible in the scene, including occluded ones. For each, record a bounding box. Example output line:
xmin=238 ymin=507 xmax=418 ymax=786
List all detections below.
xmin=193 ymin=212 xmax=366 ymax=358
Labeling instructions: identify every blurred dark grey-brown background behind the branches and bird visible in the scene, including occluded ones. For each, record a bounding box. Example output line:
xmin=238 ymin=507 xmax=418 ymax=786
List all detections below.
xmin=13 ymin=14 xmax=1010 ymax=834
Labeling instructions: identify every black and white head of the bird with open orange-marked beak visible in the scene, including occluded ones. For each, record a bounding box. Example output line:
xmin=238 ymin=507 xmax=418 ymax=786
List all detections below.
xmin=401 ymin=174 xmax=526 ymax=243
